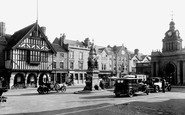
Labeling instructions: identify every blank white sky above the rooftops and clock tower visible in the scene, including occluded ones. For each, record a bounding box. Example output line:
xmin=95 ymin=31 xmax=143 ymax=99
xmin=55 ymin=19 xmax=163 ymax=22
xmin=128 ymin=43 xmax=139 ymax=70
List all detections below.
xmin=0 ymin=0 xmax=185 ymax=55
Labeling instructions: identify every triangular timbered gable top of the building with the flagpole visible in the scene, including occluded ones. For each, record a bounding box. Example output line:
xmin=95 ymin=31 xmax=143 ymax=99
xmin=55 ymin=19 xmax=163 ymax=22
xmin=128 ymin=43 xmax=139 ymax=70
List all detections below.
xmin=12 ymin=23 xmax=56 ymax=53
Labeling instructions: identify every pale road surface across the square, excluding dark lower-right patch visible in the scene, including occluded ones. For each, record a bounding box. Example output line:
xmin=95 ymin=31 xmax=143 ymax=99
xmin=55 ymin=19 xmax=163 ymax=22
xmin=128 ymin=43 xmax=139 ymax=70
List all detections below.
xmin=0 ymin=87 xmax=185 ymax=115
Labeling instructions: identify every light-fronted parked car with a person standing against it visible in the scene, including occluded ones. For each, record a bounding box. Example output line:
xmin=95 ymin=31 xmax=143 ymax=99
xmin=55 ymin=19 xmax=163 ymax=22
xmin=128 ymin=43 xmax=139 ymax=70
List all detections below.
xmin=146 ymin=77 xmax=171 ymax=92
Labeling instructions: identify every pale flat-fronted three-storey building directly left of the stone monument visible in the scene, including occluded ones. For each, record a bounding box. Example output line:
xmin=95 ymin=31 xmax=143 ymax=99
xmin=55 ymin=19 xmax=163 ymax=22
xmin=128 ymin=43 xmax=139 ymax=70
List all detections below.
xmin=53 ymin=34 xmax=91 ymax=85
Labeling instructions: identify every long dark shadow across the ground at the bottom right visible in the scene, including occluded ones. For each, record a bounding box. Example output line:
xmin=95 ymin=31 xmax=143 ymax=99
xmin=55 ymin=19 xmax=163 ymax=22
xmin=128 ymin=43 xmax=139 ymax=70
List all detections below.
xmin=3 ymin=99 xmax=185 ymax=115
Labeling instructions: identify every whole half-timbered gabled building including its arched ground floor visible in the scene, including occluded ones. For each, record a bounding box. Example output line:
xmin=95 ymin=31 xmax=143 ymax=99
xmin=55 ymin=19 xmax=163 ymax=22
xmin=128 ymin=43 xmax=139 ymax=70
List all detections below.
xmin=1 ymin=22 xmax=55 ymax=88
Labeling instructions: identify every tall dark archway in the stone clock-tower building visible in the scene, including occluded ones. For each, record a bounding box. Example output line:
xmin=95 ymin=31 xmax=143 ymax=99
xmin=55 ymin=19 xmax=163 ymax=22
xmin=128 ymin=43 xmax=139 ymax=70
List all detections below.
xmin=165 ymin=62 xmax=177 ymax=85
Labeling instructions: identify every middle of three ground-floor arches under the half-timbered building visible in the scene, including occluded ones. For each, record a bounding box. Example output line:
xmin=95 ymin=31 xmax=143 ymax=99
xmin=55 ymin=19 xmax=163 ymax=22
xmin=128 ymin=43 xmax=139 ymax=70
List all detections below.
xmin=27 ymin=73 xmax=37 ymax=87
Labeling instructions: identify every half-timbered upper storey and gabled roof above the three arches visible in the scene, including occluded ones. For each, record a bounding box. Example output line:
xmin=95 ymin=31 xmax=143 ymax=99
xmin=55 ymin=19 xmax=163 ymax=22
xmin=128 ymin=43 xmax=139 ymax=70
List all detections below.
xmin=7 ymin=23 xmax=55 ymax=70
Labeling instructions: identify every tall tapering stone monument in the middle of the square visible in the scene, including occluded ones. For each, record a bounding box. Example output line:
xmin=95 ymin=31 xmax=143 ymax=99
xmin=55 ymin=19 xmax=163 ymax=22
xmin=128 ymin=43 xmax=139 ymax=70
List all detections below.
xmin=84 ymin=43 xmax=99 ymax=90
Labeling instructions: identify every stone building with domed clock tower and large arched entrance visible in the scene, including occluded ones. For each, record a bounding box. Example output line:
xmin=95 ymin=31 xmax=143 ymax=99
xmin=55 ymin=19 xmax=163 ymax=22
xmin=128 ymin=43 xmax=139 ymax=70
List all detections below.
xmin=151 ymin=20 xmax=185 ymax=85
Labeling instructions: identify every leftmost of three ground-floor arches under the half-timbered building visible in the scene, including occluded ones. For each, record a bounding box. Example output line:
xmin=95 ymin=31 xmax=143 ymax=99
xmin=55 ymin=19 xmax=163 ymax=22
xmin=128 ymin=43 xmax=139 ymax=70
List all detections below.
xmin=14 ymin=73 xmax=25 ymax=88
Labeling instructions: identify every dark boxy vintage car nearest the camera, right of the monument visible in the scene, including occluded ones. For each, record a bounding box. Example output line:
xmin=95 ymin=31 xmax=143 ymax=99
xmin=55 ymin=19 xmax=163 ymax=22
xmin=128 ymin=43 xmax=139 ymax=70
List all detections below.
xmin=114 ymin=77 xmax=149 ymax=97
